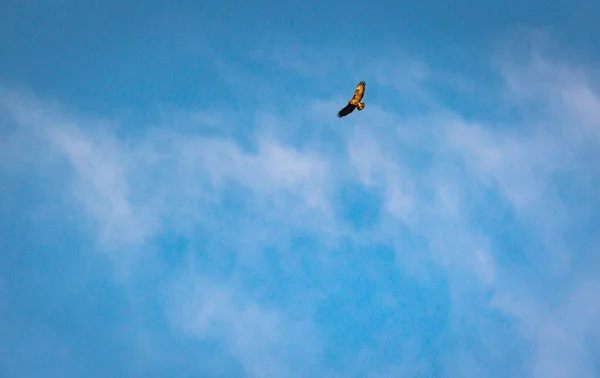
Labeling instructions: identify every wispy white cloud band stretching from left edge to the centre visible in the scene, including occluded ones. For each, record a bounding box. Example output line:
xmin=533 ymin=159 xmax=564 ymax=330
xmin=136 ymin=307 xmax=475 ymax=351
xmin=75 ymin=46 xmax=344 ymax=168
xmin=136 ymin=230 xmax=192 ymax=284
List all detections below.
xmin=3 ymin=87 xmax=329 ymax=250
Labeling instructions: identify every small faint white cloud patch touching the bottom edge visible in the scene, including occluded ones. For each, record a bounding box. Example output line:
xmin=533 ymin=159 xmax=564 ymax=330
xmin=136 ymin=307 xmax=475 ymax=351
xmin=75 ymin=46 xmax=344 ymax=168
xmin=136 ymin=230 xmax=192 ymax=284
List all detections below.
xmin=169 ymin=273 xmax=321 ymax=377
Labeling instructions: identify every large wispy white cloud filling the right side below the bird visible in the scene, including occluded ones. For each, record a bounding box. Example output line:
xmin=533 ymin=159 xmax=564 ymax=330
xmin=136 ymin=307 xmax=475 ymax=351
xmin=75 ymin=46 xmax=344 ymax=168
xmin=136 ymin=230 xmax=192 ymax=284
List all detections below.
xmin=340 ymin=34 xmax=600 ymax=377
